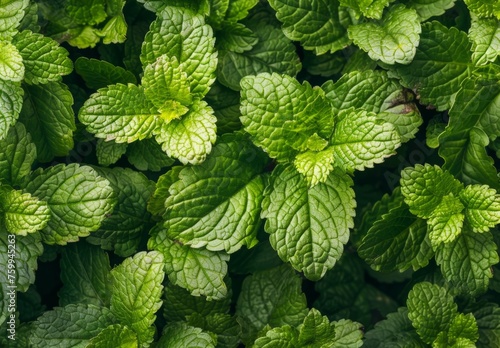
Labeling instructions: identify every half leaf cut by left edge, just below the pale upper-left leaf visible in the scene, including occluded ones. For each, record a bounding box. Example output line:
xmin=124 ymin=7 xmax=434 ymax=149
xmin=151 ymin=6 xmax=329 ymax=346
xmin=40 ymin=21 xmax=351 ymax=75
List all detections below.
xmin=0 ymin=80 xmax=24 ymax=141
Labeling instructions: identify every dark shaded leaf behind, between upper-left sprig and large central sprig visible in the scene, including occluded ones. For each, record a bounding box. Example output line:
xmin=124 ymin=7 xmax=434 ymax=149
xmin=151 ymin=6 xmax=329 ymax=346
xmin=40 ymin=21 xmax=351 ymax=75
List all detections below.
xmin=217 ymin=24 xmax=302 ymax=91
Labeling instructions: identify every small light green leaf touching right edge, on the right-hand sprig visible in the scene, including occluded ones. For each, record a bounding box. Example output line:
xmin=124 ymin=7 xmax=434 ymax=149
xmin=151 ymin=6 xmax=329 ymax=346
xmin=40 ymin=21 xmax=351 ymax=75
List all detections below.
xmin=460 ymin=185 xmax=500 ymax=232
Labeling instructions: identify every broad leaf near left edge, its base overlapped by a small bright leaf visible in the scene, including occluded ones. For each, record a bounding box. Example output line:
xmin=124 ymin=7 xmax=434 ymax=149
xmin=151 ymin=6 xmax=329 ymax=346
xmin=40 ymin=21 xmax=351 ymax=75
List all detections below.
xmin=26 ymin=163 xmax=116 ymax=245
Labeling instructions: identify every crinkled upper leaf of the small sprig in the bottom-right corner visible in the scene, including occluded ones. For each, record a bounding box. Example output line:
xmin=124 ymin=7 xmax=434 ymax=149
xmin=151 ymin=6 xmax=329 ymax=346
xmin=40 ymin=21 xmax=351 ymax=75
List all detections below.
xmin=406 ymin=282 xmax=457 ymax=344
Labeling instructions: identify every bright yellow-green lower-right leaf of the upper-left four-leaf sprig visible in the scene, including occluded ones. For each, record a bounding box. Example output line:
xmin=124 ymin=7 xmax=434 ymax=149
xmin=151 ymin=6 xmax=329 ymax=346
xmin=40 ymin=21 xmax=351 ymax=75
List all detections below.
xmin=155 ymin=100 xmax=217 ymax=164
